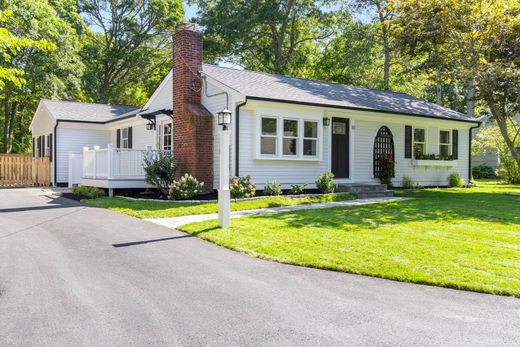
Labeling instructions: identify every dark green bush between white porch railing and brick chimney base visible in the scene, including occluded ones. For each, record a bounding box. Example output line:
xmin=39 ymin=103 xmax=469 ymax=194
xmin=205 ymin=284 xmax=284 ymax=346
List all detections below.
xmin=143 ymin=151 xmax=177 ymax=196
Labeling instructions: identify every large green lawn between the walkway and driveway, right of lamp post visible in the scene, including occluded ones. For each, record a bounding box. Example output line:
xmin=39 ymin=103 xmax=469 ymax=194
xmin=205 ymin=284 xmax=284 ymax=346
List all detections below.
xmin=181 ymin=182 xmax=520 ymax=297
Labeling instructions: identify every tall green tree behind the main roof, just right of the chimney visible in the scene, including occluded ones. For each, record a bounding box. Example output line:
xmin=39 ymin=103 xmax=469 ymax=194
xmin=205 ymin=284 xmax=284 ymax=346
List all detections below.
xmin=192 ymin=0 xmax=335 ymax=76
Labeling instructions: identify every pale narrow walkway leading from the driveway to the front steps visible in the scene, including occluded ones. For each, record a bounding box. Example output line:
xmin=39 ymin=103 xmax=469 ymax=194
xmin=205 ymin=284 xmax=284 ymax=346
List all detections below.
xmin=145 ymin=197 xmax=410 ymax=229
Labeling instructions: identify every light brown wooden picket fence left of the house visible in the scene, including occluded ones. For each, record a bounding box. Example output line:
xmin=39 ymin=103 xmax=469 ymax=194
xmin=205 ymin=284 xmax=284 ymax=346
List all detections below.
xmin=0 ymin=154 xmax=51 ymax=188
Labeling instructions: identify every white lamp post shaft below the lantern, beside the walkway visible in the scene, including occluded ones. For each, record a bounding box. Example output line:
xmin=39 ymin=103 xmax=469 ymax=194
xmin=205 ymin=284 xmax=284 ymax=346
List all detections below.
xmin=218 ymin=130 xmax=231 ymax=228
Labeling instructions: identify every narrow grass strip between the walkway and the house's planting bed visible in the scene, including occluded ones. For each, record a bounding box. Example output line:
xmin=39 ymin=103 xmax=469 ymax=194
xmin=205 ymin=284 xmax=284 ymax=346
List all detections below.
xmin=85 ymin=194 xmax=355 ymax=218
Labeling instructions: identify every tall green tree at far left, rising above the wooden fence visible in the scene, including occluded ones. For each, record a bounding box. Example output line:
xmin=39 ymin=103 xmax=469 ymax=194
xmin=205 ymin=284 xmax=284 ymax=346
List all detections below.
xmin=0 ymin=0 xmax=83 ymax=153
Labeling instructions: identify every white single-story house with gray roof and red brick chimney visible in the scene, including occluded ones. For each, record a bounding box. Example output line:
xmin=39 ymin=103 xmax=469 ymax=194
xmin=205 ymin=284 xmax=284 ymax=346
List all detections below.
xmin=31 ymin=24 xmax=479 ymax=193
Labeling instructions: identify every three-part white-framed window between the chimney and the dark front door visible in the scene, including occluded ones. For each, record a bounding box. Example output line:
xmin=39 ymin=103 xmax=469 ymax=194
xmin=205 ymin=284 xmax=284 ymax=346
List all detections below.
xmin=259 ymin=116 xmax=321 ymax=160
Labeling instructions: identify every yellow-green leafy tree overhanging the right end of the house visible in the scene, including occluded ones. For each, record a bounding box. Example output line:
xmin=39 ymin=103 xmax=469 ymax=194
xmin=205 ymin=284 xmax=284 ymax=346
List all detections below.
xmin=391 ymin=0 xmax=520 ymax=167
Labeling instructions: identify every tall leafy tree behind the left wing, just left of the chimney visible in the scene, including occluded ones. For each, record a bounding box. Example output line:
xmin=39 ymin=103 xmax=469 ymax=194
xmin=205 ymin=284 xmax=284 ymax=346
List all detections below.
xmin=78 ymin=0 xmax=184 ymax=106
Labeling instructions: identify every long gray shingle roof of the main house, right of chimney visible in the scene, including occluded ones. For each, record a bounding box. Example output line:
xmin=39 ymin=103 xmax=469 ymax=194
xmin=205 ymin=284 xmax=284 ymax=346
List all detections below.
xmin=203 ymin=64 xmax=477 ymax=122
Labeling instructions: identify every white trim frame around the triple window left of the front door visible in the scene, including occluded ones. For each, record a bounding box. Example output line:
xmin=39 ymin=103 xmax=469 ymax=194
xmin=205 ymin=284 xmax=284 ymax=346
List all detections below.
xmin=255 ymin=114 xmax=323 ymax=161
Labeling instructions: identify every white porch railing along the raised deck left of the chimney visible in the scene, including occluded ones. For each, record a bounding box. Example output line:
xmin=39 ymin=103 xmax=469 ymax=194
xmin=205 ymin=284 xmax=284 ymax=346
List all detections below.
xmin=83 ymin=145 xmax=171 ymax=179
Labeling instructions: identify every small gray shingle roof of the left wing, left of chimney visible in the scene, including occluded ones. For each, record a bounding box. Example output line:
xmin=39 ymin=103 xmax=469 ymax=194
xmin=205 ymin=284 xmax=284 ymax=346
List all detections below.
xmin=42 ymin=100 xmax=139 ymax=122
